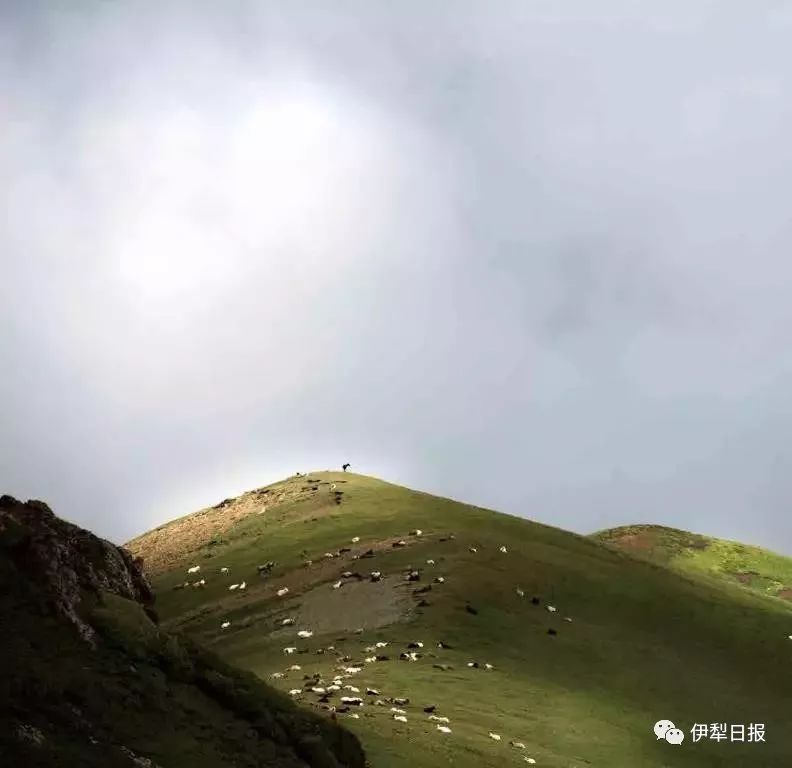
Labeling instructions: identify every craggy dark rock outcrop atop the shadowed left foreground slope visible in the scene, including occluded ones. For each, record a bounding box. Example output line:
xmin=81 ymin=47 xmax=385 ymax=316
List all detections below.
xmin=0 ymin=496 xmax=154 ymax=644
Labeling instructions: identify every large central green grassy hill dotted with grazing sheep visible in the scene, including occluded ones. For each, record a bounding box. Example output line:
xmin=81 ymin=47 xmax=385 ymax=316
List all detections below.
xmin=127 ymin=472 xmax=792 ymax=768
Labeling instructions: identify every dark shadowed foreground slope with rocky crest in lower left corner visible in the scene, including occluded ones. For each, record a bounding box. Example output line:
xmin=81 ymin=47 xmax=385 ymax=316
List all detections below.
xmin=0 ymin=496 xmax=365 ymax=768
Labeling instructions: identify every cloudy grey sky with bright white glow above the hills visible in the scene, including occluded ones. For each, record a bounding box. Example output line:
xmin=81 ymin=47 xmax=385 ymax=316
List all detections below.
xmin=0 ymin=0 xmax=792 ymax=554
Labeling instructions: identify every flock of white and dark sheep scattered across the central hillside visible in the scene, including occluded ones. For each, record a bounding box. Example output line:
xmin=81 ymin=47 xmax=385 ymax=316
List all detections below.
xmin=179 ymin=529 xmax=572 ymax=764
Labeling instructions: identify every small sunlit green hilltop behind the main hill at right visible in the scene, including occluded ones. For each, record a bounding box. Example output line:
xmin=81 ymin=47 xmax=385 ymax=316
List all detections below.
xmin=592 ymin=525 xmax=792 ymax=601
